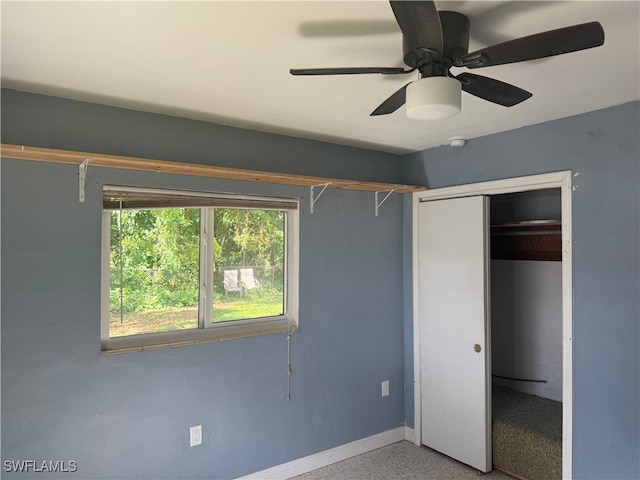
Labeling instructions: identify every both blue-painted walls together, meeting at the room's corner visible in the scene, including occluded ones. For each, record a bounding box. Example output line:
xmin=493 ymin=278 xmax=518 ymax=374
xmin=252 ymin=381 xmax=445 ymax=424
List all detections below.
xmin=1 ymin=90 xmax=640 ymax=478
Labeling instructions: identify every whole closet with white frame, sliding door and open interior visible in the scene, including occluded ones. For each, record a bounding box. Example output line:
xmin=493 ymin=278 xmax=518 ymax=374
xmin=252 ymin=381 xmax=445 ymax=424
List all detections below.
xmin=413 ymin=171 xmax=577 ymax=480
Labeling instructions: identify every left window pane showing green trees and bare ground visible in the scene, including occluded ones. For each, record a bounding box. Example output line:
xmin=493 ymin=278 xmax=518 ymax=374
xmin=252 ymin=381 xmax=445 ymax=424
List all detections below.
xmin=109 ymin=208 xmax=200 ymax=337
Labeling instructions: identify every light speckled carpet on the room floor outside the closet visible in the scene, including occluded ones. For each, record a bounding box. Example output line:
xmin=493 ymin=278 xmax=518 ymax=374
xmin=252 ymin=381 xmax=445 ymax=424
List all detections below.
xmin=294 ymin=441 xmax=513 ymax=480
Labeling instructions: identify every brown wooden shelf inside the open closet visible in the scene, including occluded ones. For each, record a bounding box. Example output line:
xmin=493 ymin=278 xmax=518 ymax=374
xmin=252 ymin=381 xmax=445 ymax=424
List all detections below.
xmin=491 ymin=219 xmax=562 ymax=262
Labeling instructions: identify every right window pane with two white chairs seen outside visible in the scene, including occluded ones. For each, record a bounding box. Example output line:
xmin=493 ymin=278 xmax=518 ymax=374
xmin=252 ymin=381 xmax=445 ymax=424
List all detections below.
xmin=213 ymin=208 xmax=285 ymax=322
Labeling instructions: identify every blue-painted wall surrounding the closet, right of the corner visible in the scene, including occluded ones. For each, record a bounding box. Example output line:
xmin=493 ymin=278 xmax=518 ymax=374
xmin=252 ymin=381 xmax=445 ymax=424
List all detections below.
xmin=405 ymin=102 xmax=640 ymax=479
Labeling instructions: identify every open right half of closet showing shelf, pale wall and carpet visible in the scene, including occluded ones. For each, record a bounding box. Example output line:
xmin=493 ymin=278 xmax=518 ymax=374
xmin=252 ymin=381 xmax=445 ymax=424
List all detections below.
xmin=489 ymin=188 xmax=563 ymax=480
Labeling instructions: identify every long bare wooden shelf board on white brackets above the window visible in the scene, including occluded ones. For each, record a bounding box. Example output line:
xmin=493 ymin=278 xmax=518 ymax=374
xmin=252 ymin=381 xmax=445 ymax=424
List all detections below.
xmin=0 ymin=143 xmax=428 ymax=193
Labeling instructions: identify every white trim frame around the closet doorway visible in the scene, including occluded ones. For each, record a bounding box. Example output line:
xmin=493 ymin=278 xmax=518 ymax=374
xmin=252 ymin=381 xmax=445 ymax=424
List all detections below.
xmin=412 ymin=170 xmax=573 ymax=478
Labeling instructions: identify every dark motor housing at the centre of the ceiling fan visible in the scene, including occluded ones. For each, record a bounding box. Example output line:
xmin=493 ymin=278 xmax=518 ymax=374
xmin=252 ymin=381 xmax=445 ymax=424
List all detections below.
xmin=402 ymin=11 xmax=470 ymax=73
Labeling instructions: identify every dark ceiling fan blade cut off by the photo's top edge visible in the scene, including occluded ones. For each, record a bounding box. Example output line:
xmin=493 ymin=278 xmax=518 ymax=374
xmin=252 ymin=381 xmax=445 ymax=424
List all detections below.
xmin=389 ymin=1 xmax=443 ymax=54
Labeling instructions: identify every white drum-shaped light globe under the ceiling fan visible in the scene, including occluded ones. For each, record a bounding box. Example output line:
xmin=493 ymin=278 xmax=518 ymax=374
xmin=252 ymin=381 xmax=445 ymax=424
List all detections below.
xmin=406 ymin=77 xmax=462 ymax=120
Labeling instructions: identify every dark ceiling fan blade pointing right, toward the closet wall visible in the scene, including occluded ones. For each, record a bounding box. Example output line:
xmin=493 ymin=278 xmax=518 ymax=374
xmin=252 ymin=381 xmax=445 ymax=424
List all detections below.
xmin=454 ymin=22 xmax=604 ymax=68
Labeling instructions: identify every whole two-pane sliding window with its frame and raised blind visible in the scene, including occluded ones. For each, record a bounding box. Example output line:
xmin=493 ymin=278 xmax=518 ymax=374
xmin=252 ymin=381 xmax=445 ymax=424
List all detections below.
xmin=101 ymin=186 xmax=299 ymax=352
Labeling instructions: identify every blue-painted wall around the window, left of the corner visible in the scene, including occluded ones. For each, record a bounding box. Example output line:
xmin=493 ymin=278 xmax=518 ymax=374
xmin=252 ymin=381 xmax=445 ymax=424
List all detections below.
xmin=1 ymin=90 xmax=404 ymax=478
